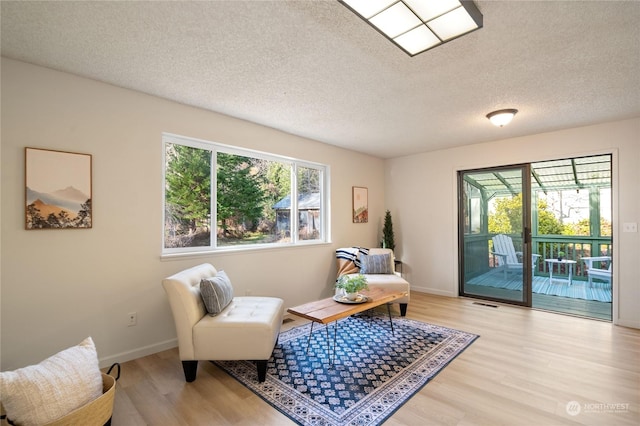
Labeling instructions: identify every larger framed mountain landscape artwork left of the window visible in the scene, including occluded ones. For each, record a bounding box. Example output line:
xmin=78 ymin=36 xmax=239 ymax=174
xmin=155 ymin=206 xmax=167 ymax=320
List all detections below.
xmin=25 ymin=148 xmax=92 ymax=229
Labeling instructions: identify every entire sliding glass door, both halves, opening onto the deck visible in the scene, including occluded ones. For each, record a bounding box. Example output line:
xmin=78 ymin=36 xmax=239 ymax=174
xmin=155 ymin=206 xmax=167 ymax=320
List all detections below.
xmin=458 ymin=154 xmax=615 ymax=321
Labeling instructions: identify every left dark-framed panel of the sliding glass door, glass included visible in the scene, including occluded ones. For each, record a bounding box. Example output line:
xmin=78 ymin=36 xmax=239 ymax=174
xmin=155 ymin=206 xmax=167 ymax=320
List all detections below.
xmin=458 ymin=164 xmax=536 ymax=306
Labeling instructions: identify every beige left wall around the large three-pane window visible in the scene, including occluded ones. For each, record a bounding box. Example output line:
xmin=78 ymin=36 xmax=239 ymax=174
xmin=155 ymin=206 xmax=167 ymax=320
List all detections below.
xmin=1 ymin=58 xmax=384 ymax=370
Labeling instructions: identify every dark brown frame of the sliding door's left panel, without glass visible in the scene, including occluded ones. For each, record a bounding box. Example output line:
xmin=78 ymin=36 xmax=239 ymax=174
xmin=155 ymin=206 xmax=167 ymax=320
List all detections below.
xmin=457 ymin=163 xmax=533 ymax=307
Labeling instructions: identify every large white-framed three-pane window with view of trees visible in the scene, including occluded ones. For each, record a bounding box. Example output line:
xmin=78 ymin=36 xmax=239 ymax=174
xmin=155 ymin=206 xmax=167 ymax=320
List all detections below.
xmin=163 ymin=135 xmax=328 ymax=254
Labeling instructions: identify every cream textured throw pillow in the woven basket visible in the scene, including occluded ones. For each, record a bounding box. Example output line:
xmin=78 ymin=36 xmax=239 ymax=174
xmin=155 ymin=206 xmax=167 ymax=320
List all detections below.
xmin=0 ymin=337 xmax=102 ymax=426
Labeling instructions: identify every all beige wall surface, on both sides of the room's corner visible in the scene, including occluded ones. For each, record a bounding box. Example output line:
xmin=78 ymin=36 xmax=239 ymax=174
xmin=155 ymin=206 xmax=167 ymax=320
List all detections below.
xmin=0 ymin=58 xmax=640 ymax=370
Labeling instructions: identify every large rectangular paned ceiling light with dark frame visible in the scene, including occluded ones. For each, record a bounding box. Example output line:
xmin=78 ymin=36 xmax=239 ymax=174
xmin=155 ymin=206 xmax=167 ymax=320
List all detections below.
xmin=338 ymin=0 xmax=482 ymax=56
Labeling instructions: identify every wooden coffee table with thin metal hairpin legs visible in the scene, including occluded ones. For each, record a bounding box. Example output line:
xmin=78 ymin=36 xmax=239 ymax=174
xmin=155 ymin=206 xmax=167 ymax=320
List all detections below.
xmin=287 ymin=288 xmax=407 ymax=364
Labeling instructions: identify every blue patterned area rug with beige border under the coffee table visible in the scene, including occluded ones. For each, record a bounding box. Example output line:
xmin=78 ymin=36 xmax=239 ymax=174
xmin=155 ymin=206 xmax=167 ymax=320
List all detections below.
xmin=215 ymin=315 xmax=479 ymax=426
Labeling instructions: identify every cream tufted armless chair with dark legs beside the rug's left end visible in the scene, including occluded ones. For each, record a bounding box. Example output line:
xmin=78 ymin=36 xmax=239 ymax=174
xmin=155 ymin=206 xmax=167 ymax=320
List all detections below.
xmin=162 ymin=263 xmax=284 ymax=382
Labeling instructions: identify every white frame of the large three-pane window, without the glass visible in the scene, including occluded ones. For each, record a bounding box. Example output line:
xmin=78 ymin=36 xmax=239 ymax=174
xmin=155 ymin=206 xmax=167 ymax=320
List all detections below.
xmin=161 ymin=133 xmax=331 ymax=257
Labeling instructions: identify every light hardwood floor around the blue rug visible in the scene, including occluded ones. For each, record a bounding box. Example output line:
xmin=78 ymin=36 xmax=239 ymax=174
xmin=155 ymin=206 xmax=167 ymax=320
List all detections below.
xmin=112 ymin=292 xmax=640 ymax=426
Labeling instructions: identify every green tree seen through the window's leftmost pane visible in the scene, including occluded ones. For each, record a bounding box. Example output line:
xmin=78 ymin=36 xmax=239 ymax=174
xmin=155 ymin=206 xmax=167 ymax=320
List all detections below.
xmin=166 ymin=144 xmax=211 ymax=234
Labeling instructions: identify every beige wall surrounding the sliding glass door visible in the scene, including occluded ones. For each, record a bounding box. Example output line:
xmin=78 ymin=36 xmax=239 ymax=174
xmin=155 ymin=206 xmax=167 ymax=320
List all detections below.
xmin=385 ymin=118 xmax=640 ymax=328
